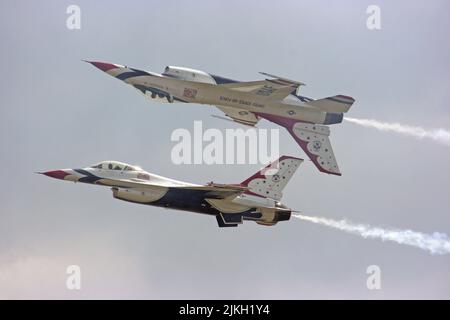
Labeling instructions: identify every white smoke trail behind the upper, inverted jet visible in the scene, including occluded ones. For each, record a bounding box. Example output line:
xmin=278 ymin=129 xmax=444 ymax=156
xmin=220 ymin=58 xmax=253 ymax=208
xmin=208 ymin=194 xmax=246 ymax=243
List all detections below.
xmin=344 ymin=117 xmax=450 ymax=146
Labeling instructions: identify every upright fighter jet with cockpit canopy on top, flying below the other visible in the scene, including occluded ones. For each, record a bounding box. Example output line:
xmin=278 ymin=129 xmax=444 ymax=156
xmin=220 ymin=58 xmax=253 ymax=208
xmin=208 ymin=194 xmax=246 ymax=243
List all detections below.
xmin=40 ymin=156 xmax=303 ymax=227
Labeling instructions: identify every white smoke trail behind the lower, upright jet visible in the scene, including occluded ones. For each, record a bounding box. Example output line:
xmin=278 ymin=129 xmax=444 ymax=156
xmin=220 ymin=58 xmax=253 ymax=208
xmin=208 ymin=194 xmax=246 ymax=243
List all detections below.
xmin=292 ymin=214 xmax=450 ymax=254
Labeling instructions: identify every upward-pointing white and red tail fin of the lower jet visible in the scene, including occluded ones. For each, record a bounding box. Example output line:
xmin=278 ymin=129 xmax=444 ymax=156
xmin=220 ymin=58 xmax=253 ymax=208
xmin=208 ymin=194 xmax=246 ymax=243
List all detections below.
xmin=241 ymin=156 xmax=303 ymax=200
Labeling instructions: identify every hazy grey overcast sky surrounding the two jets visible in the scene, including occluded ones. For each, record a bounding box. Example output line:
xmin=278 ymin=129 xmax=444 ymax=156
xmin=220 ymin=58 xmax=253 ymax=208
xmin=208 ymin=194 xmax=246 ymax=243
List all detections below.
xmin=0 ymin=0 xmax=450 ymax=299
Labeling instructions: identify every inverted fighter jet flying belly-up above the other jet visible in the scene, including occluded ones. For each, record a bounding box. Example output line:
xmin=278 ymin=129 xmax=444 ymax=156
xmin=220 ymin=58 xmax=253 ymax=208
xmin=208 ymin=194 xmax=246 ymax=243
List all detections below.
xmin=88 ymin=61 xmax=355 ymax=175
